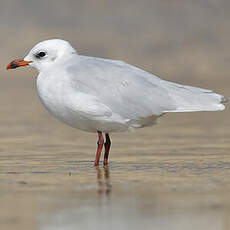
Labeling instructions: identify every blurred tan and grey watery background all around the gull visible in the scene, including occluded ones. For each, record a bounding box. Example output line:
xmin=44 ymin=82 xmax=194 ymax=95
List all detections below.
xmin=0 ymin=0 xmax=230 ymax=230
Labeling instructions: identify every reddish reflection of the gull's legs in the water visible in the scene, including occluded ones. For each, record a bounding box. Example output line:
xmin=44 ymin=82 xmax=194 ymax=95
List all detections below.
xmin=95 ymin=166 xmax=112 ymax=196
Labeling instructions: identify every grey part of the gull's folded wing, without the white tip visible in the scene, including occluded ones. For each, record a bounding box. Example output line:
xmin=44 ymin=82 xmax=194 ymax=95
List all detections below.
xmin=67 ymin=56 xmax=176 ymax=119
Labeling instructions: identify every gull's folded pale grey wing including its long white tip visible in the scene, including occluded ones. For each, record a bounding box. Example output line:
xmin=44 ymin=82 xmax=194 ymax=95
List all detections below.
xmin=67 ymin=56 xmax=224 ymax=119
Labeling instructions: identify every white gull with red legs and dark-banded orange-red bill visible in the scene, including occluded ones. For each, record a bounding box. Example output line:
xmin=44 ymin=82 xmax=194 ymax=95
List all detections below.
xmin=7 ymin=39 xmax=227 ymax=165
